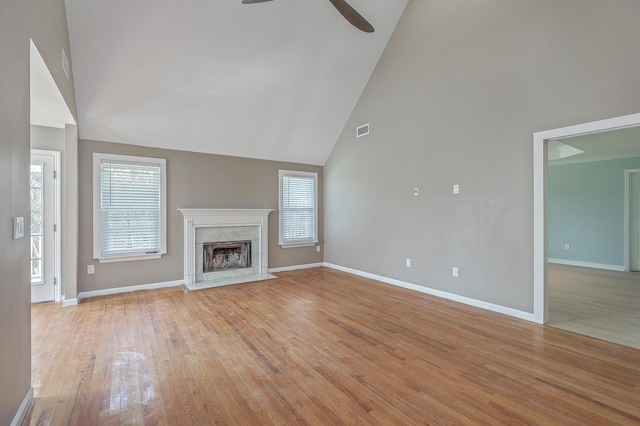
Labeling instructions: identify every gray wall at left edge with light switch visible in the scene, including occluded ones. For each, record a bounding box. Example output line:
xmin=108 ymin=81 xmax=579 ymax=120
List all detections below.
xmin=0 ymin=0 xmax=75 ymax=425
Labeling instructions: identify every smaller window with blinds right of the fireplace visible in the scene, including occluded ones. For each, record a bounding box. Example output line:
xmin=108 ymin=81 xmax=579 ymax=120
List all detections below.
xmin=280 ymin=170 xmax=318 ymax=247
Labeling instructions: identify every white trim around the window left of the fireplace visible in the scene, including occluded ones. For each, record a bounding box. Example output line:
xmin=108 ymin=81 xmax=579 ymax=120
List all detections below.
xmin=93 ymin=152 xmax=167 ymax=263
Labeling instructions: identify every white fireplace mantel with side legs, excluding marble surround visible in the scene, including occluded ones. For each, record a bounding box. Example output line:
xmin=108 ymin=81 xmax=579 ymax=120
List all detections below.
xmin=179 ymin=209 xmax=273 ymax=289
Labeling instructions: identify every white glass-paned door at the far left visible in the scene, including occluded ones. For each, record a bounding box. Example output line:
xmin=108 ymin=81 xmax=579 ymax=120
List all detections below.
xmin=30 ymin=154 xmax=56 ymax=303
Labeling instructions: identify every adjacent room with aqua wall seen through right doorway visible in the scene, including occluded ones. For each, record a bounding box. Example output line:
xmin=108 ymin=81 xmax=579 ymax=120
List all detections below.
xmin=547 ymin=127 xmax=640 ymax=349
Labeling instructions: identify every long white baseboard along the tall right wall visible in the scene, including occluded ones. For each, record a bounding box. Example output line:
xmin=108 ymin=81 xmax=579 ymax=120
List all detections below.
xmin=324 ymin=262 xmax=534 ymax=322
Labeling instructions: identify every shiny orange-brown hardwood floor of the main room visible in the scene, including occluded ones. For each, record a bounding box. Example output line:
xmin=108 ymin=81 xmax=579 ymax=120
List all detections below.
xmin=26 ymin=268 xmax=640 ymax=425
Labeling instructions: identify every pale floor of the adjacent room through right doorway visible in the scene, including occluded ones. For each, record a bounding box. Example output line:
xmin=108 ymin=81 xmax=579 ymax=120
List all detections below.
xmin=547 ymin=264 xmax=640 ymax=349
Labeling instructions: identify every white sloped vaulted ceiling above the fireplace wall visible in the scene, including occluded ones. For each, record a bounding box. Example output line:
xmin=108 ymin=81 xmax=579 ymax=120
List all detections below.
xmin=66 ymin=0 xmax=408 ymax=165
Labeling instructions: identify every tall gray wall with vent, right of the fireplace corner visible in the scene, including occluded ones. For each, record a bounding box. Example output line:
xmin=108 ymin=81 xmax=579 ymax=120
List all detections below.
xmin=325 ymin=0 xmax=640 ymax=313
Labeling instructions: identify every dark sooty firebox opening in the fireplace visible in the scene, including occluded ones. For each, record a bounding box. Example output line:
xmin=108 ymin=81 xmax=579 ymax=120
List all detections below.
xmin=202 ymin=241 xmax=251 ymax=274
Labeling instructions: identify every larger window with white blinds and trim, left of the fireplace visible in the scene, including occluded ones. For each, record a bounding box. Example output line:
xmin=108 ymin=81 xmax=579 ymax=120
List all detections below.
xmin=93 ymin=153 xmax=167 ymax=262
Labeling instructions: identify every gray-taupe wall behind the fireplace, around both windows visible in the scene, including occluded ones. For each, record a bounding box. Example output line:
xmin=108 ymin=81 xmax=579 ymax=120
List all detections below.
xmin=78 ymin=140 xmax=324 ymax=292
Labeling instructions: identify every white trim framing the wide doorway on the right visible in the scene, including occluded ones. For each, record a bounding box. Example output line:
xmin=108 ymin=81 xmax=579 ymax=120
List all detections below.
xmin=533 ymin=113 xmax=640 ymax=324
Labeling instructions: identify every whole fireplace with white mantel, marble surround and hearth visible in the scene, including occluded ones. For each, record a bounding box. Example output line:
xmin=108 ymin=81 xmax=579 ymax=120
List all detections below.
xmin=180 ymin=209 xmax=275 ymax=290
